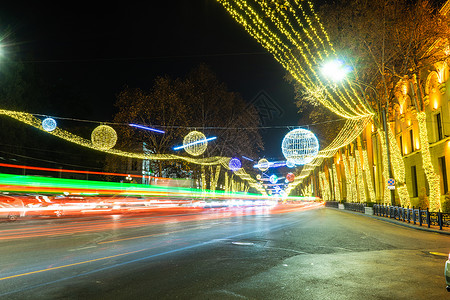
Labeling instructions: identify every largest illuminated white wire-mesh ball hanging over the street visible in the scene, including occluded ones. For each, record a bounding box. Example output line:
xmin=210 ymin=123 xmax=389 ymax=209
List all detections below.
xmin=281 ymin=128 xmax=319 ymax=165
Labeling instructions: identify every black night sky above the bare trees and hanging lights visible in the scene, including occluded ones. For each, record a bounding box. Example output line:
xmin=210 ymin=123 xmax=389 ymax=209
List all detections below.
xmin=0 ymin=0 xmax=299 ymax=159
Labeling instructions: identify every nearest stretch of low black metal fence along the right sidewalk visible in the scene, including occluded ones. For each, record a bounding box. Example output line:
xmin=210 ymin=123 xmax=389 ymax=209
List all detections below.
xmin=373 ymin=204 xmax=450 ymax=230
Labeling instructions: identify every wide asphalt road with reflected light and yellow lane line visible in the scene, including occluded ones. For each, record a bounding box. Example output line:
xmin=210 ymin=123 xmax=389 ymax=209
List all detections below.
xmin=0 ymin=204 xmax=450 ymax=299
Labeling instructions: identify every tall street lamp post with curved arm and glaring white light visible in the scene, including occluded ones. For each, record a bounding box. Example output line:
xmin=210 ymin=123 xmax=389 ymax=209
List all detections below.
xmin=321 ymin=60 xmax=395 ymax=205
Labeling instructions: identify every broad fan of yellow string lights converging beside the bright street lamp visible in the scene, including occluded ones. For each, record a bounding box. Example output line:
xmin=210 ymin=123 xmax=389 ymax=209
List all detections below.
xmin=218 ymin=0 xmax=372 ymax=118
